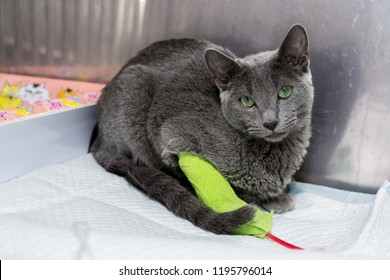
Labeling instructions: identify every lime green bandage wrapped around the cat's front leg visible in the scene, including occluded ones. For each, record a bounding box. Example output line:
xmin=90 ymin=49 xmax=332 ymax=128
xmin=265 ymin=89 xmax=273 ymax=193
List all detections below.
xmin=178 ymin=154 xmax=273 ymax=237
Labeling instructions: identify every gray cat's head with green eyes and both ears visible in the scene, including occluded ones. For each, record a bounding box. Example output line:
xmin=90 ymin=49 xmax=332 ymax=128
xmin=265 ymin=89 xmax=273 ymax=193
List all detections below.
xmin=205 ymin=25 xmax=313 ymax=142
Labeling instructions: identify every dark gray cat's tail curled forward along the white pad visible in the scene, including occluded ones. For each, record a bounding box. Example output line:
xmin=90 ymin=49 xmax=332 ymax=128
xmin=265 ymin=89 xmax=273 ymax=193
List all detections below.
xmin=94 ymin=151 xmax=256 ymax=234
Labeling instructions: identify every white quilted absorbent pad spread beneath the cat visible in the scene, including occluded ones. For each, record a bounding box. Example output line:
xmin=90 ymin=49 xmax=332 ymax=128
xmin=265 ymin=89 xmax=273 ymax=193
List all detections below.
xmin=0 ymin=154 xmax=390 ymax=259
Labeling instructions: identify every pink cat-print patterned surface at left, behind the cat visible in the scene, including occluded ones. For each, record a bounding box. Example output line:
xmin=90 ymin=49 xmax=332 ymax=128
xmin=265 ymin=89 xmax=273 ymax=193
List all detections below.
xmin=0 ymin=73 xmax=104 ymax=123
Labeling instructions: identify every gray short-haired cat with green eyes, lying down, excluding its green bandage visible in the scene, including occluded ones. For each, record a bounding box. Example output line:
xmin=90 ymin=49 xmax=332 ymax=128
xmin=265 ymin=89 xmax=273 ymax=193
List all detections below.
xmin=91 ymin=25 xmax=313 ymax=234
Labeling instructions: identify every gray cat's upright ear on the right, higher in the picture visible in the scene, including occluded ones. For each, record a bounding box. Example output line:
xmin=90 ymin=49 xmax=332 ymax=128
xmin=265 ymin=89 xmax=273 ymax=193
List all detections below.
xmin=278 ymin=24 xmax=309 ymax=72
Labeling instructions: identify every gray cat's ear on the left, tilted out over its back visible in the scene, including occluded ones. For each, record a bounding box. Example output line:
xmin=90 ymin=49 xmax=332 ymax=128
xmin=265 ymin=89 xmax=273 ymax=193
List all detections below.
xmin=204 ymin=49 xmax=241 ymax=90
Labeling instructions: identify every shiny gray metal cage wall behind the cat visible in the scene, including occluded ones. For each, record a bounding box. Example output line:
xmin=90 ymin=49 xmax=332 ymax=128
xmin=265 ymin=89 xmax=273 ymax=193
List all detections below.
xmin=0 ymin=0 xmax=390 ymax=192
